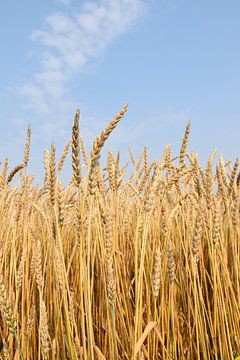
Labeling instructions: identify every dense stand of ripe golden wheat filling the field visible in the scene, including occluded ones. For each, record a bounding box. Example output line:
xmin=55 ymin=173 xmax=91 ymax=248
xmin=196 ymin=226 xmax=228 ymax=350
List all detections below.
xmin=0 ymin=106 xmax=240 ymax=360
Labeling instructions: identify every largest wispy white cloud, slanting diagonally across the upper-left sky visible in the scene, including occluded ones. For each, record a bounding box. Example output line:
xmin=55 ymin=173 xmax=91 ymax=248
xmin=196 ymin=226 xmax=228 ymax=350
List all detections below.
xmin=18 ymin=0 xmax=146 ymax=113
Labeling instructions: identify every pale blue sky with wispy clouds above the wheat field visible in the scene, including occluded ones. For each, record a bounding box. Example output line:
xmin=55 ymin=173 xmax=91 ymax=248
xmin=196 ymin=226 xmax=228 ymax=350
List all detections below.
xmin=0 ymin=0 xmax=240 ymax=180
